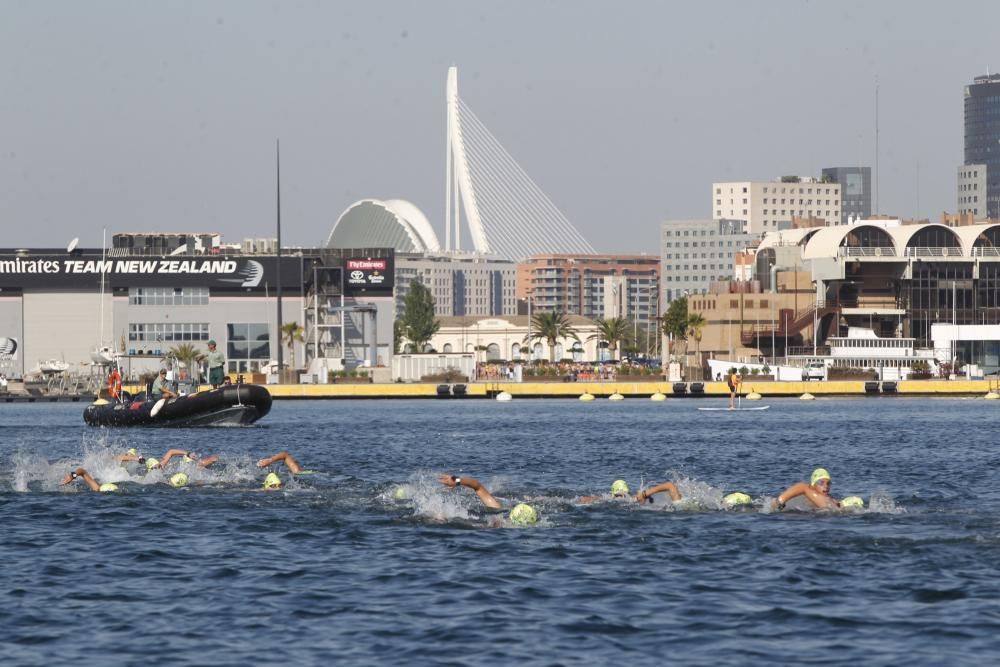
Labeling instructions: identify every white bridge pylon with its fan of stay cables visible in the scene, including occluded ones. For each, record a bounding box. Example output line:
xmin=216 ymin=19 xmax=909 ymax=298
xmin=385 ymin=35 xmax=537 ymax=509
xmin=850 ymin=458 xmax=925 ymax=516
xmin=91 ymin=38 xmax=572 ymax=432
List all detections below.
xmin=445 ymin=67 xmax=596 ymax=262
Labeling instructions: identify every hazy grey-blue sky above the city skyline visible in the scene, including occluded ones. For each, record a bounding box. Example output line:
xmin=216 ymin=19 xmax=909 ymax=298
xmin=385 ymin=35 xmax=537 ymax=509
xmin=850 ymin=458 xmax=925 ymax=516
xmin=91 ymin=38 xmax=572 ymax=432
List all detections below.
xmin=0 ymin=0 xmax=1000 ymax=254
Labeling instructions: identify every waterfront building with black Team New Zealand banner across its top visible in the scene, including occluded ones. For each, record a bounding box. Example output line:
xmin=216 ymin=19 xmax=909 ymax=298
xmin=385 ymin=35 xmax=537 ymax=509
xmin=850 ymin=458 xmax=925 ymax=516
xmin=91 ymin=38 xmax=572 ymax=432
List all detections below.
xmin=0 ymin=239 xmax=393 ymax=377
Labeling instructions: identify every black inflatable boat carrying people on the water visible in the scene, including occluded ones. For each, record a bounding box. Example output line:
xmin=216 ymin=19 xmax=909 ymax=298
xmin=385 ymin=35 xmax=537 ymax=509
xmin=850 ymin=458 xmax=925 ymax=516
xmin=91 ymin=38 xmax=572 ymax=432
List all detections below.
xmin=83 ymin=384 xmax=271 ymax=427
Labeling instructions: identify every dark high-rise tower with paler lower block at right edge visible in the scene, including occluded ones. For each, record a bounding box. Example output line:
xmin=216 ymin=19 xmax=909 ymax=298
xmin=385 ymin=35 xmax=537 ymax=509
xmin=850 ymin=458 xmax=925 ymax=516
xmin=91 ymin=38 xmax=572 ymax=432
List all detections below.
xmin=958 ymin=74 xmax=1000 ymax=218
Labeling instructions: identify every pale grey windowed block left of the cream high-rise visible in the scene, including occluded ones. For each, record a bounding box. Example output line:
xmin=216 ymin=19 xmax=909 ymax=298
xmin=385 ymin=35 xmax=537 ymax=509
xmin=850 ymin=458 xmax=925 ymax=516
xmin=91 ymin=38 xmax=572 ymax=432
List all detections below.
xmin=660 ymin=219 xmax=754 ymax=304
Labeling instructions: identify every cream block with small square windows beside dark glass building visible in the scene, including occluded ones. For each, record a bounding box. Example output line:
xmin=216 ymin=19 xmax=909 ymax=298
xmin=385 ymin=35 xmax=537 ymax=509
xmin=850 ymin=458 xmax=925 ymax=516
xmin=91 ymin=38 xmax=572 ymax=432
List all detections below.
xmin=712 ymin=176 xmax=841 ymax=234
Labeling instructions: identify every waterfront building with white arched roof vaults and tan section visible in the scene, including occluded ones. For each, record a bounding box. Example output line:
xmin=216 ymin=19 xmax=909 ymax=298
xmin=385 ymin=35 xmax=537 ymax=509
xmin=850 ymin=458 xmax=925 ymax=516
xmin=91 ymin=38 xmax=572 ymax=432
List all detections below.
xmin=689 ymin=219 xmax=1000 ymax=372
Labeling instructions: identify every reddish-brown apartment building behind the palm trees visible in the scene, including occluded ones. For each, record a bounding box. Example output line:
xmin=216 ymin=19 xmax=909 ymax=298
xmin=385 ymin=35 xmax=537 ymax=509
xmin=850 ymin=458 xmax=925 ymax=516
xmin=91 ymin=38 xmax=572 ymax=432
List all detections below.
xmin=517 ymin=254 xmax=660 ymax=326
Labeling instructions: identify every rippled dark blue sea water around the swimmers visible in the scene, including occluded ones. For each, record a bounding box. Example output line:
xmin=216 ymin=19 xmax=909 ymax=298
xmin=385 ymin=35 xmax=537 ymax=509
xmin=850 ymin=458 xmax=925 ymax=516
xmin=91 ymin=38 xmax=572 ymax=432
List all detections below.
xmin=0 ymin=398 xmax=1000 ymax=665
